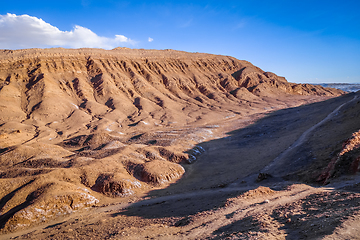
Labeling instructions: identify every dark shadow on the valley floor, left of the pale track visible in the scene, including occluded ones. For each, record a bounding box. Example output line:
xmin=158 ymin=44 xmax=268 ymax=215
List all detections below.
xmin=113 ymin=94 xmax=353 ymax=238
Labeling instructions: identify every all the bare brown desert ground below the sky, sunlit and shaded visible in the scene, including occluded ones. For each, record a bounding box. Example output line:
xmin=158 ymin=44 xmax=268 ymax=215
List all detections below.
xmin=0 ymin=48 xmax=360 ymax=239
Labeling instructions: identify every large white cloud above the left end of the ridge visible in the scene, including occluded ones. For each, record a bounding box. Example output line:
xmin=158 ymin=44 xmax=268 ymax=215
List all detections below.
xmin=0 ymin=13 xmax=135 ymax=49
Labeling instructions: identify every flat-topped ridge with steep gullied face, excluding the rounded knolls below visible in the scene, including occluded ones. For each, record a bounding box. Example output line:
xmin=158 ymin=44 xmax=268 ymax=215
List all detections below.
xmin=0 ymin=49 xmax=341 ymax=127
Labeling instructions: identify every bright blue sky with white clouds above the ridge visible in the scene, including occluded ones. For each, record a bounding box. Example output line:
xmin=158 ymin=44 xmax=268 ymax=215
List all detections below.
xmin=0 ymin=0 xmax=360 ymax=83
